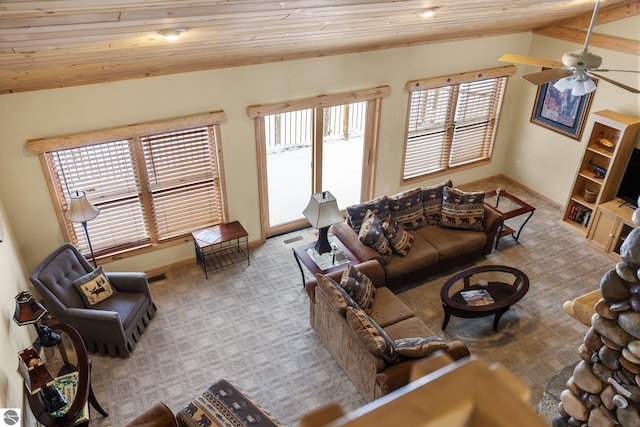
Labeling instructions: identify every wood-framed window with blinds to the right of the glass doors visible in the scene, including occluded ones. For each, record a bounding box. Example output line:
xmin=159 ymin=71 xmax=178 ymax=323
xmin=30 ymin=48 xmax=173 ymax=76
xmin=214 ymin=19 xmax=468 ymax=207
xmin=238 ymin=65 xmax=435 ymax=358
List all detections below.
xmin=402 ymin=66 xmax=515 ymax=182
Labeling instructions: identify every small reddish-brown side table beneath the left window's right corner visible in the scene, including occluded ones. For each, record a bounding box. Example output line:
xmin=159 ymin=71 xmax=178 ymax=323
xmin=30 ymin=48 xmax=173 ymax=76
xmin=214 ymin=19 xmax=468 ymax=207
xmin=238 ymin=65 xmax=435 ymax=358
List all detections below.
xmin=191 ymin=221 xmax=251 ymax=279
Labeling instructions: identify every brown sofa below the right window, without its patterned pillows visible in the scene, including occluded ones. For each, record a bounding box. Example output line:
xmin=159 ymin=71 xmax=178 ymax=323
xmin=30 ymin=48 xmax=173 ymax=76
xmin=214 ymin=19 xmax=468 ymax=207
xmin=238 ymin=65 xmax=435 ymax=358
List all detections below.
xmin=330 ymin=206 xmax=503 ymax=288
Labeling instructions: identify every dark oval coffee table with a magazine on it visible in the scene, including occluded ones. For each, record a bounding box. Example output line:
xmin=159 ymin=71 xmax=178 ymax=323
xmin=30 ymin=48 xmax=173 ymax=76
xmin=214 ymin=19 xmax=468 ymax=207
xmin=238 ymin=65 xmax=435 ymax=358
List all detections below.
xmin=440 ymin=265 xmax=529 ymax=331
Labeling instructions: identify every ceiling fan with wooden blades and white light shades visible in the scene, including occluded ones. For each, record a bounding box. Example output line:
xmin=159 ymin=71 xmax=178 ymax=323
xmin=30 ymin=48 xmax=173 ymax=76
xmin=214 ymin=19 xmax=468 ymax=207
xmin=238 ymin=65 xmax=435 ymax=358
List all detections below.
xmin=500 ymin=0 xmax=640 ymax=96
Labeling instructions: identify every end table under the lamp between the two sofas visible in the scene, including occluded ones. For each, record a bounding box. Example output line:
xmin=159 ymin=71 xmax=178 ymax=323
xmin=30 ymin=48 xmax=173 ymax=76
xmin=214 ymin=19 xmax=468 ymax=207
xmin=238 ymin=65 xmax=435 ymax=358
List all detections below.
xmin=293 ymin=236 xmax=361 ymax=287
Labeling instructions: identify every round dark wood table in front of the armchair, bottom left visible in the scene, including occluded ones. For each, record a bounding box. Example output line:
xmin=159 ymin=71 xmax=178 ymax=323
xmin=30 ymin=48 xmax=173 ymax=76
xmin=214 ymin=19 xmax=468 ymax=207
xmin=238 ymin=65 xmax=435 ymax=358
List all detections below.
xmin=24 ymin=323 xmax=108 ymax=427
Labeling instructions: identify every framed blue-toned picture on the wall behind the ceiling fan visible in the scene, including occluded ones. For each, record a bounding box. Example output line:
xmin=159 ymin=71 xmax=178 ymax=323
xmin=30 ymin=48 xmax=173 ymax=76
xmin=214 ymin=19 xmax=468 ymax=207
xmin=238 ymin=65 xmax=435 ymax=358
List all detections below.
xmin=531 ymin=79 xmax=598 ymax=140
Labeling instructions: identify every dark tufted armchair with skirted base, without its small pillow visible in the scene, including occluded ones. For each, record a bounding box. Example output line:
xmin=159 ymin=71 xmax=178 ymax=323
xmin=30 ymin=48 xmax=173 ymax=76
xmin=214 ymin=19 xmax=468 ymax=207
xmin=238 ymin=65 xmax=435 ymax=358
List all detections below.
xmin=29 ymin=243 xmax=156 ymax=357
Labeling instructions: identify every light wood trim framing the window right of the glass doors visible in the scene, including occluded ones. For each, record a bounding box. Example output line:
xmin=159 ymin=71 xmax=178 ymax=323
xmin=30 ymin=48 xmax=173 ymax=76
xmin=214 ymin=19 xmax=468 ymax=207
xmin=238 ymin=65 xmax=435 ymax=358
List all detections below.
xmin=400 ymin=65 xmax=517 ymax=185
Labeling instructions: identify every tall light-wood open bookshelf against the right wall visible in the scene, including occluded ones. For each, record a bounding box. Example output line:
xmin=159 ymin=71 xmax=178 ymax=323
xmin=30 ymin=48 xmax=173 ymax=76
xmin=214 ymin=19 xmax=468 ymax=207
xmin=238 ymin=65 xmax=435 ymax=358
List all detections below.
xmin=562 ymin=110 xmax=640 ymax=237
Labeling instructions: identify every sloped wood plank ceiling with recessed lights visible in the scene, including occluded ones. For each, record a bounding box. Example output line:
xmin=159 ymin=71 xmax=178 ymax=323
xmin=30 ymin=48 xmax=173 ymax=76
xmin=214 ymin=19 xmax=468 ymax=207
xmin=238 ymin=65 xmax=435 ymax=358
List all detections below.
xmin=0 ymin=0 xmax=640 ymax=94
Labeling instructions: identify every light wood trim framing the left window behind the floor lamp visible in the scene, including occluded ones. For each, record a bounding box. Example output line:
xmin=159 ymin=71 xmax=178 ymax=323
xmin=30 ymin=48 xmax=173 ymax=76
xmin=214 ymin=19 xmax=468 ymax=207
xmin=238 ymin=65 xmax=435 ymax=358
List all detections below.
xmin=27 ymin=110 xmax=228 ymax=260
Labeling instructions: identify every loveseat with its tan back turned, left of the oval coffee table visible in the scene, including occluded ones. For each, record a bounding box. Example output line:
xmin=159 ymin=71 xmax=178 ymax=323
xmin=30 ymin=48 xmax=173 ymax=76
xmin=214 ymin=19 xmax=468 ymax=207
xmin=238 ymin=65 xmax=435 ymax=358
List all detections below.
xmin=305 ymin=260 xmax=469 ymax=401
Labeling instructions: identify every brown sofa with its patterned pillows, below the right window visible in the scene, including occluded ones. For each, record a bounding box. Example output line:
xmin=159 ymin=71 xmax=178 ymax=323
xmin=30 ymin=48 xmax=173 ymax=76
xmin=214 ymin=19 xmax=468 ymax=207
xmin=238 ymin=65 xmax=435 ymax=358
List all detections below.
xmin=330 ymin=180 xmax=503 ymax=288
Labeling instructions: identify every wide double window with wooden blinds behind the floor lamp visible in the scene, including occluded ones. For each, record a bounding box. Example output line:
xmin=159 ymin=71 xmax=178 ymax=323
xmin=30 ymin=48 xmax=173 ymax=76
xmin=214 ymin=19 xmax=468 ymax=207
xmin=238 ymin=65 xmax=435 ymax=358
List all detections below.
xmin=29 ymin=112 xmax=225 ymax=255
